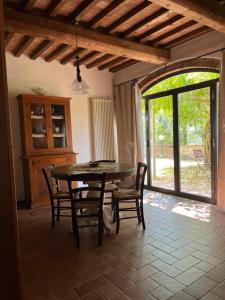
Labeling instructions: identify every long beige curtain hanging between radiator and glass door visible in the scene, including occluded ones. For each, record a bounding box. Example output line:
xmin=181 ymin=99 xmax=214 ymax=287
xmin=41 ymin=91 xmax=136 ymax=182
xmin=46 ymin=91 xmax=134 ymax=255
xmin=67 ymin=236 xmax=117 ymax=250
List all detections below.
xmin=114 ymin=82 xmax=144 ymax=165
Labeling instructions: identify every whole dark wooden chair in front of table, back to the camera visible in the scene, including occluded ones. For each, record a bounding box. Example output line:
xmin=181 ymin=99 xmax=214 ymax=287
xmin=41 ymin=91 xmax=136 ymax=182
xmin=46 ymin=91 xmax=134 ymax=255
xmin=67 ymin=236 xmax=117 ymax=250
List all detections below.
xmin=68 ymin=173 xmax=106 ymax=248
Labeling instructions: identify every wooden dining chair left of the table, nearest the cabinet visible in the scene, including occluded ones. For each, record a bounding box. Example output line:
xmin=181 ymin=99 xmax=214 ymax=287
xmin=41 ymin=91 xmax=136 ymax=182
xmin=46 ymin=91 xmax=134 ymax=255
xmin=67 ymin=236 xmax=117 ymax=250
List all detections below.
xmin=42 ymin=165 xmax=71 ymax=228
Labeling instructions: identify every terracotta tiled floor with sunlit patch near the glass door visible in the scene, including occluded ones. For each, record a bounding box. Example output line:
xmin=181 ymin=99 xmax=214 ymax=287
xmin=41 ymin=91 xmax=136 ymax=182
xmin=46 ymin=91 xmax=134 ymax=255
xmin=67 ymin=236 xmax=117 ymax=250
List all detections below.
xmin=19 ymin=192 xmax=225 ymax=300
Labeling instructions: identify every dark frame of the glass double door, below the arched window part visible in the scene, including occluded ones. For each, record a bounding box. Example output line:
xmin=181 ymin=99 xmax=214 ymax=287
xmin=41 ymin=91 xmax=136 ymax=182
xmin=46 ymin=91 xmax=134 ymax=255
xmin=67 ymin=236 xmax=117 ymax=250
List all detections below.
xmin=142 ymin=78 xmax=219 ymax=204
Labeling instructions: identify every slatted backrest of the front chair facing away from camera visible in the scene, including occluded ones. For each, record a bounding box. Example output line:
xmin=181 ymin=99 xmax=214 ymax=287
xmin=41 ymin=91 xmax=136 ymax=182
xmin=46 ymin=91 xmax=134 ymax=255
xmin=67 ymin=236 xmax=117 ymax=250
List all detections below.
xmin=68 ymin=173 xmax=107 ymax=207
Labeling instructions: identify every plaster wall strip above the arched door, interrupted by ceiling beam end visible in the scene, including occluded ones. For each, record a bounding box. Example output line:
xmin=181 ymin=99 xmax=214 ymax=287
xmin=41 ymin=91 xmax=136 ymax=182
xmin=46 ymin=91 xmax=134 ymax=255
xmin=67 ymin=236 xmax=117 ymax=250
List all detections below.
xmin=114 ymin=32 xmax=225 ymax=84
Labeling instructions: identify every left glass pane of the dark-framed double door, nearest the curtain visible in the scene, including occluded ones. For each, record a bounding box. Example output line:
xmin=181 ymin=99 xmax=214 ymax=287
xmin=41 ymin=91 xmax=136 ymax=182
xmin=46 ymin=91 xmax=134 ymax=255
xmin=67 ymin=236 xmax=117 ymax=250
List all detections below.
xmin=147 ymin=96 xmax=175 ymax=190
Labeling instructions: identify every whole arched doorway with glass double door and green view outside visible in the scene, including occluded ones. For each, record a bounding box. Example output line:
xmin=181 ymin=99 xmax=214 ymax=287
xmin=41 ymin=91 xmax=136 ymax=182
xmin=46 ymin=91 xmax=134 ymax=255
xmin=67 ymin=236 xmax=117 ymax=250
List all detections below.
xmin=142 ymin=68 xmax=219 ymax=203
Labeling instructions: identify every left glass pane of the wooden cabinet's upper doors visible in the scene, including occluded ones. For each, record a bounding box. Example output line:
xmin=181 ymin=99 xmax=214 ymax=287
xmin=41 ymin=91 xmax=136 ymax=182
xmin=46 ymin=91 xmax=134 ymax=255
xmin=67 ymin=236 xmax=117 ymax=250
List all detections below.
xmin=30 ymin=103 xmax=48 ymax=150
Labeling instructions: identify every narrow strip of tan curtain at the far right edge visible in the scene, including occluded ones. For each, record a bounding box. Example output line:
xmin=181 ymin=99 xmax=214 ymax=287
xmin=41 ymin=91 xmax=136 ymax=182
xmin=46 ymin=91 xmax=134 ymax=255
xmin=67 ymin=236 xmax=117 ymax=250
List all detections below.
xmin=217 ymin=52 xmax=225 ymax=209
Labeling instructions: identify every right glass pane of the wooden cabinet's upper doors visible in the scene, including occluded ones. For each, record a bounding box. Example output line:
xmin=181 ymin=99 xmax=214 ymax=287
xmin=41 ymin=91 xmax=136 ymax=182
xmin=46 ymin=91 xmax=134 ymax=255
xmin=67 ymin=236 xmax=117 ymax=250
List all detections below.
xmin=51 ymin=104 xmax=67 ymax=148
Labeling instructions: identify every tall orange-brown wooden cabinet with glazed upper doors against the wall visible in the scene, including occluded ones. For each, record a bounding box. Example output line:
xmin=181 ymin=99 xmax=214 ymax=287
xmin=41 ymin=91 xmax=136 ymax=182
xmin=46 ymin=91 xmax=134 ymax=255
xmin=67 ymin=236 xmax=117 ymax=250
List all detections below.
xmin=18 ymin=95 xmax=76 ymax=208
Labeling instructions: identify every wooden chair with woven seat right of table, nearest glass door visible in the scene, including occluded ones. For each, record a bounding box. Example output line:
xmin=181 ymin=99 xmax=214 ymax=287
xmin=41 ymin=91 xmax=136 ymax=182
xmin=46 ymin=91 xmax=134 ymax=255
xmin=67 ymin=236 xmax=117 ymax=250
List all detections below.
xmin=113 ymin=162 xmax=147 ymax=233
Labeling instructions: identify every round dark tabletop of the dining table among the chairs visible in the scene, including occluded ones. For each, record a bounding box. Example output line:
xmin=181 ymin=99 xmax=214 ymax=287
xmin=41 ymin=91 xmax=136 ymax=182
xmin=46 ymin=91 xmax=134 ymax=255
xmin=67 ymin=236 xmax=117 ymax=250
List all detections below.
xmin=51 ymin=162 xmax=136 ymax=180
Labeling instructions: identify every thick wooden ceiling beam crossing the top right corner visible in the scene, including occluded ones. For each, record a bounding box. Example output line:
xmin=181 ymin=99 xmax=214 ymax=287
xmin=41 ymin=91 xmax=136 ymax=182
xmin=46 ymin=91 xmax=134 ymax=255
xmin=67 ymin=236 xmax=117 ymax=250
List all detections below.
xmin=149 ymin=0 xmax=225 ymax=33
